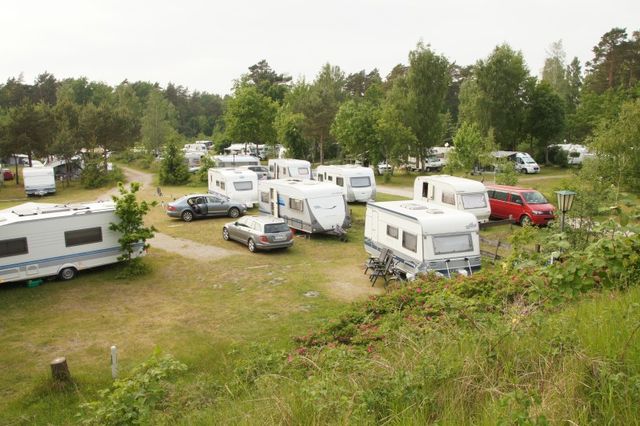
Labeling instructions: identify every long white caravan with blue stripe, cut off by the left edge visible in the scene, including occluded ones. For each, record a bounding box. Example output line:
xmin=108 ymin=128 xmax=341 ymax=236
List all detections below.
xmin=0 ymin=202 xmax=144 ymax=282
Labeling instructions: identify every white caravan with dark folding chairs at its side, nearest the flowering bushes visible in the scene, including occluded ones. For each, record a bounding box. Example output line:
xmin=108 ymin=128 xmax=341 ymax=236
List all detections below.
xmin=364 ymin=200 xmax=480 ymax=279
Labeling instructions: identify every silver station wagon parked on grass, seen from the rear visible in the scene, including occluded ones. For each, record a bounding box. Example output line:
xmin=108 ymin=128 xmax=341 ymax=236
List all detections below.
xmin=222 ymin=216 xmax=293 ymax=252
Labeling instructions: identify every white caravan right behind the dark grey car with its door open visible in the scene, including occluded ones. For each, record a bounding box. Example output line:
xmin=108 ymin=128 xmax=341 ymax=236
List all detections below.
xmin=209 ymin=168 xmax=258 ymax=208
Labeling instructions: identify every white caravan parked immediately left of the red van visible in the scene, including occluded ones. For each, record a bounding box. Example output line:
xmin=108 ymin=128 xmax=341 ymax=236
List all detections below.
xmin=413 ymin=175 xmax=491 ymax=223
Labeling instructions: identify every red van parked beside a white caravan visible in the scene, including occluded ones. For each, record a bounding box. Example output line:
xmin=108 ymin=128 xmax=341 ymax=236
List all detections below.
xmin=485 ymin=185 xmax=556 ymax=225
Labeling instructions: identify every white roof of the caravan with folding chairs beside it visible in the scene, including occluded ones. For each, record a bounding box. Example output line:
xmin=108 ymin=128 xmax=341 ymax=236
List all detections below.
xmin=367 ymin=200 xmax=478 ymax=234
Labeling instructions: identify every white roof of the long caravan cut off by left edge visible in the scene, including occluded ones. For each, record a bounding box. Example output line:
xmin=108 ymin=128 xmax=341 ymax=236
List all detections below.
xmin=0 ymin=201 xmax=116 ymax=227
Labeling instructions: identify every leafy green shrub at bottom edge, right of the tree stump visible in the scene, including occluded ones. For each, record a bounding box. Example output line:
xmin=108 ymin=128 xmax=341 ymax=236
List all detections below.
xmin=79 ymin=351 xmax=187 ymax=426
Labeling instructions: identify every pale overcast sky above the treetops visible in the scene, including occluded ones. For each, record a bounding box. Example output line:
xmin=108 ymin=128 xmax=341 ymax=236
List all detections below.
xmin=0 ymin=0 xmax=640 ymax=95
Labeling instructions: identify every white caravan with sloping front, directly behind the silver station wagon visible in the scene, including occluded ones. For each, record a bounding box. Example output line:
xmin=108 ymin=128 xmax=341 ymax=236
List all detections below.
xmin=258 ymin=179 xmax=351 ymax=236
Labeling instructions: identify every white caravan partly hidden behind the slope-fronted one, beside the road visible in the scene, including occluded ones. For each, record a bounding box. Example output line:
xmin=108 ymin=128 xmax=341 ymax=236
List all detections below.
xmin=316 ymin=164 xmax=376 ymax=203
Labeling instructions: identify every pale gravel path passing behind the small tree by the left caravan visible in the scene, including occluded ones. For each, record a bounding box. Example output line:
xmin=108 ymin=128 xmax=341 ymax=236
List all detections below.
xmin=100 ymin=167 xmax=238 ymax=262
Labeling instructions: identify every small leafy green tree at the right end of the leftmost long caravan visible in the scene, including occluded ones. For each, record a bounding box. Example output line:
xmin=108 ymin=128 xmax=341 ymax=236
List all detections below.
xmin=109 ymin=182 xmax=156 ymax=262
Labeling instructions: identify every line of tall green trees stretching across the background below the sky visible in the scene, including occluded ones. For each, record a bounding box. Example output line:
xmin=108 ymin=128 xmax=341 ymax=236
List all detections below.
xmin=0 ymin=28 xmax=640 ymax=188
